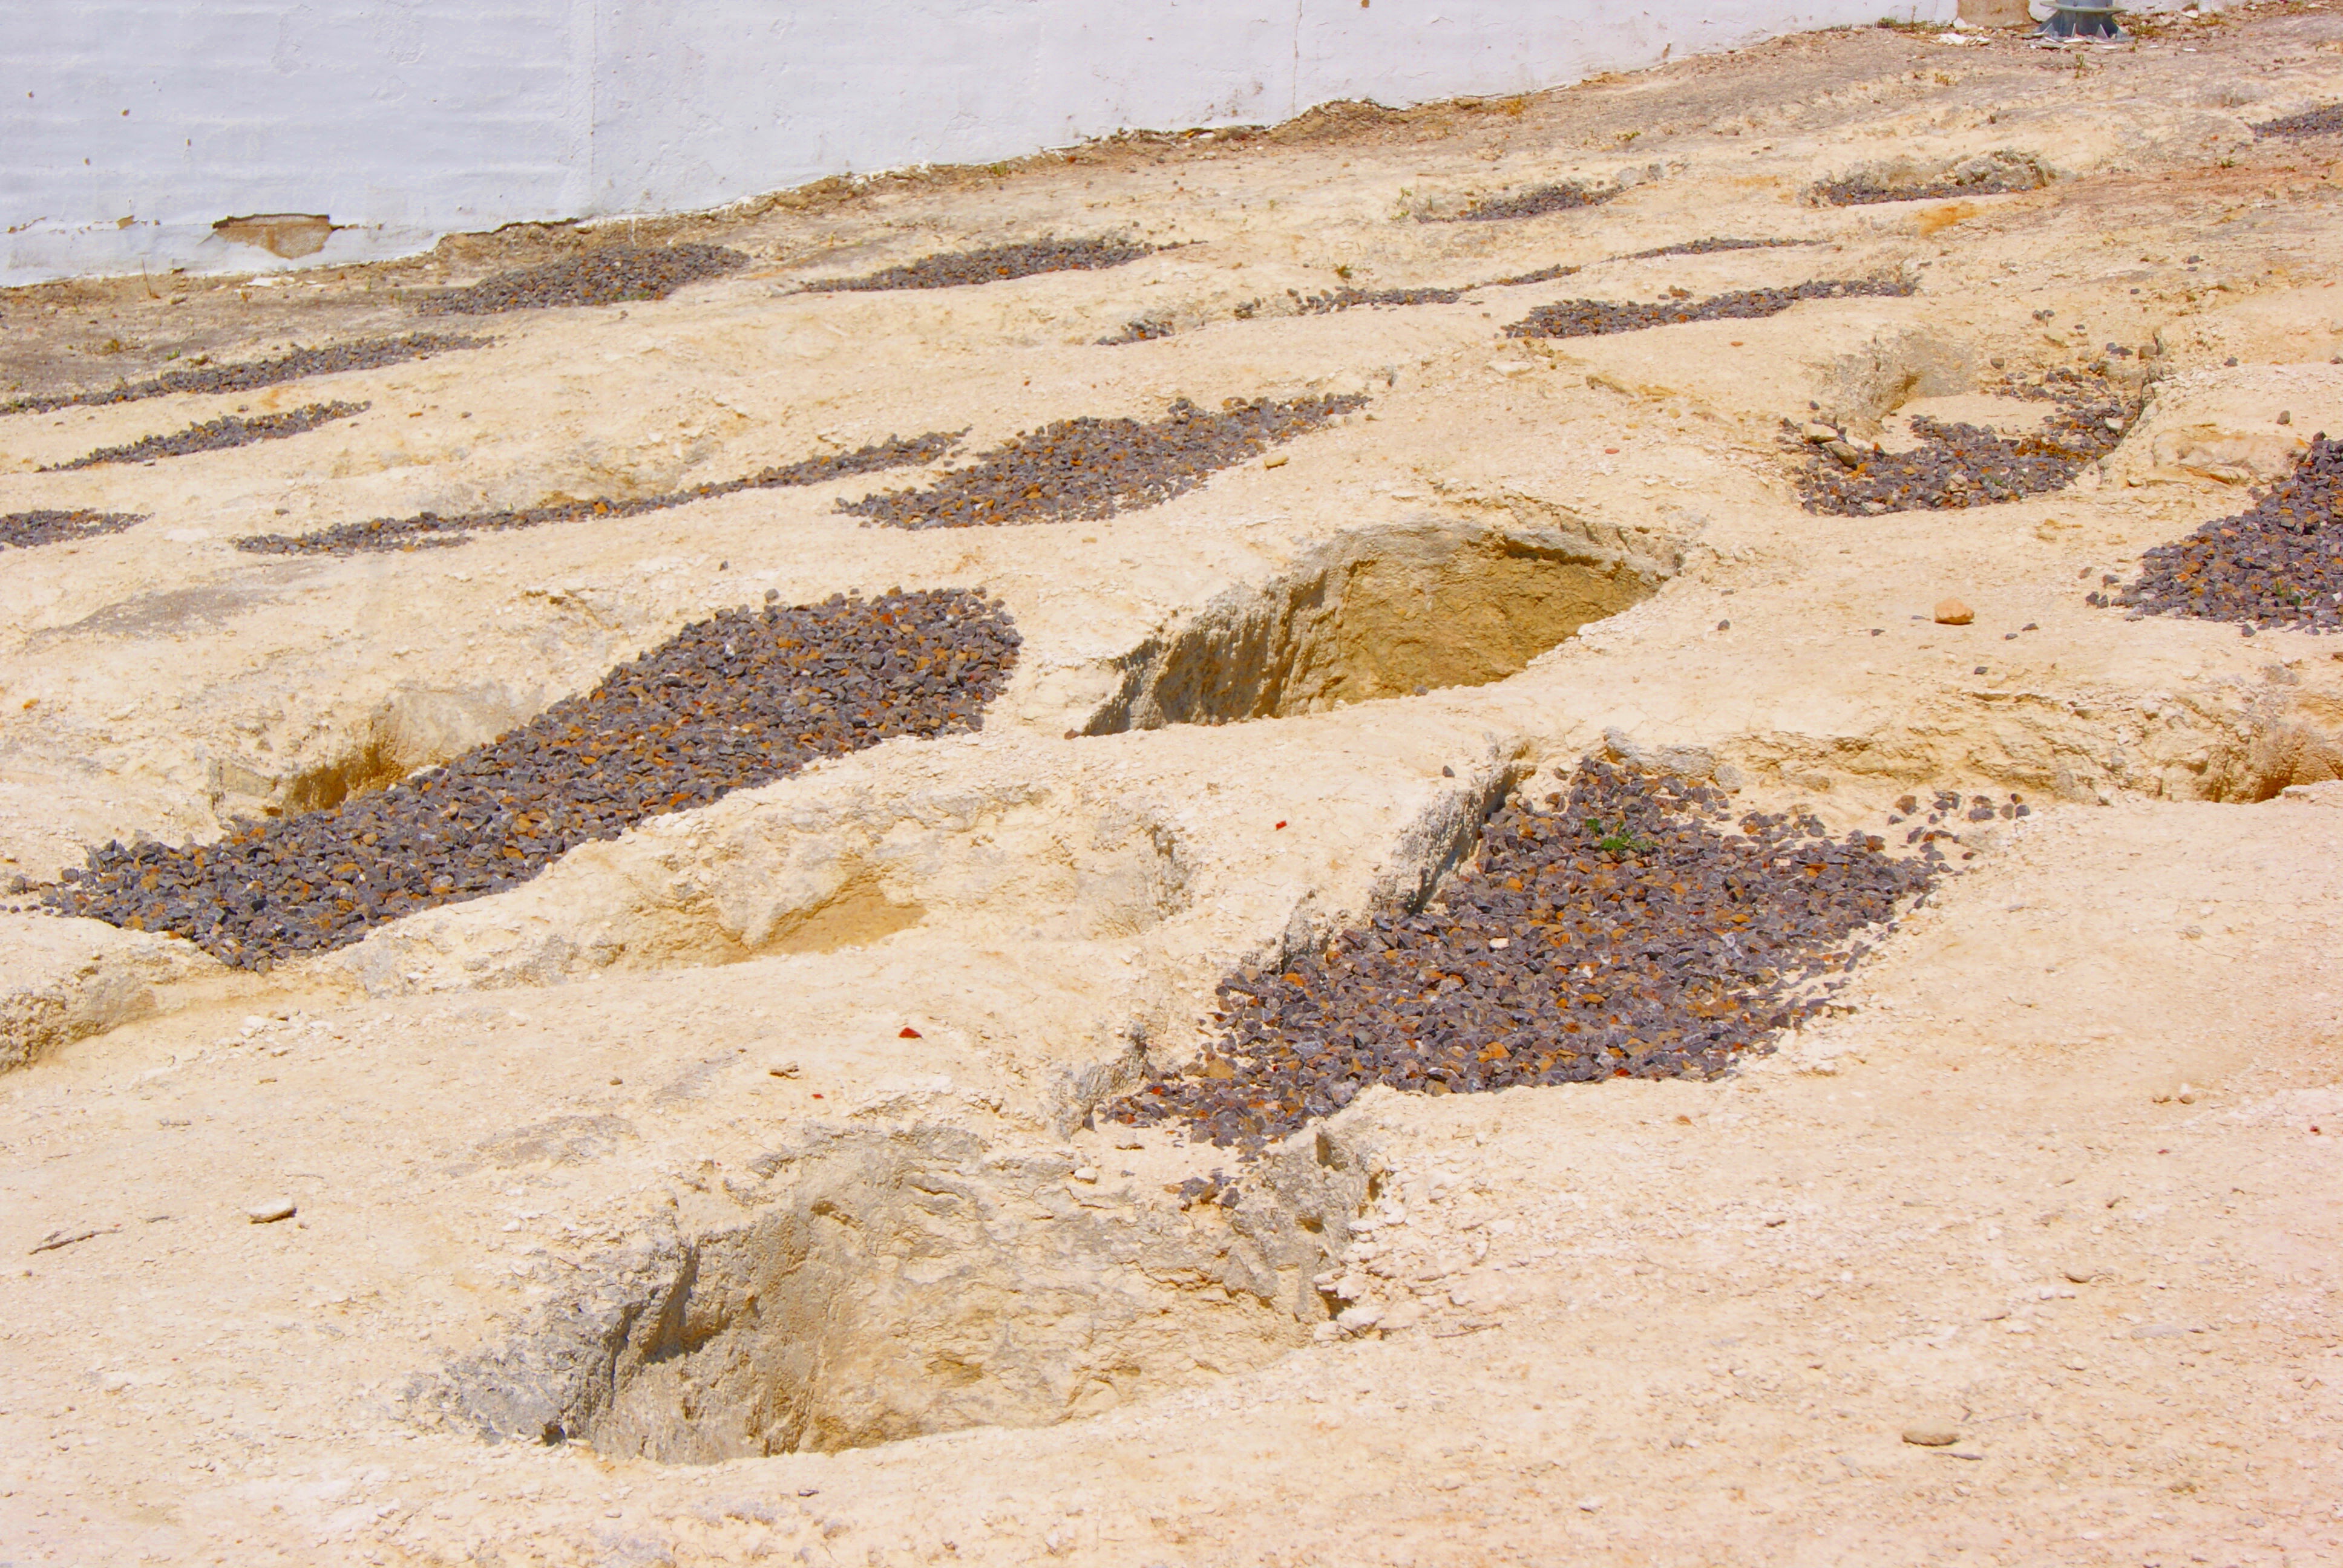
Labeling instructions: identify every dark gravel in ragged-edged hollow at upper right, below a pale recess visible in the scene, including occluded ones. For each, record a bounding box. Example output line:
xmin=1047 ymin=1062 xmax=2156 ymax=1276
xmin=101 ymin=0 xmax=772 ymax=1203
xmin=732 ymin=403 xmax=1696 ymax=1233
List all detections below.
xmin=1783 ymin=370 xmax=2139 ymax=515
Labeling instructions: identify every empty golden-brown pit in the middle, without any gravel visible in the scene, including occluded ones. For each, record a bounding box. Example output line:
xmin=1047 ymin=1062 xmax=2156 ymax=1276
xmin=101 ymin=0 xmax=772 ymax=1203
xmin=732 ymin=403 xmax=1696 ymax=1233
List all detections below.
xmin=1085 ymin=523 xmax=1661 ymax=736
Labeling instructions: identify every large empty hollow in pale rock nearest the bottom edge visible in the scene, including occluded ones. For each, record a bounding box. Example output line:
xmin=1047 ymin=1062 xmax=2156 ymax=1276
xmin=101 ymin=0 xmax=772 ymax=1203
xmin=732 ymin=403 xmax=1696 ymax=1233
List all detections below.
xmin=405 ymin=1125 xmax=1382 ymax=1463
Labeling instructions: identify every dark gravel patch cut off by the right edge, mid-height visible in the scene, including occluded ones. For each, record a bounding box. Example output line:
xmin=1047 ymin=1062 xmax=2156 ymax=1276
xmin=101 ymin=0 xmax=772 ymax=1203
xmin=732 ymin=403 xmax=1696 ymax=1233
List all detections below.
xmin=2090 ymin=431 xmax=2343 ymax=630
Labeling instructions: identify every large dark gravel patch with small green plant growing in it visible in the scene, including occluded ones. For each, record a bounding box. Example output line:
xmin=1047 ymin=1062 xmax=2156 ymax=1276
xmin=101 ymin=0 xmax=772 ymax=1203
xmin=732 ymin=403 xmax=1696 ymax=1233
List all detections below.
xmin=1104 ymin=762 xmax=1951 ymax=1151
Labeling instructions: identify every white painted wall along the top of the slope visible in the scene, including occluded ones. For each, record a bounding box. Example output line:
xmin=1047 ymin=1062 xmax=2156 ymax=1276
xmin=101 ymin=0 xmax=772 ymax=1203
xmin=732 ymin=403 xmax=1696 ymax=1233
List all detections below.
xmin=0 ymin=0 xmax=1956 ymax=284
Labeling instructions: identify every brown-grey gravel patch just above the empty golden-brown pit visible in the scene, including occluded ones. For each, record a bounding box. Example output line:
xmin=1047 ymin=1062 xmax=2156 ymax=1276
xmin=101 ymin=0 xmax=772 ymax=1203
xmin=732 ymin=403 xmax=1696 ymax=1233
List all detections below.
xmin=839 ymin=394 xmax=1366 ymax=528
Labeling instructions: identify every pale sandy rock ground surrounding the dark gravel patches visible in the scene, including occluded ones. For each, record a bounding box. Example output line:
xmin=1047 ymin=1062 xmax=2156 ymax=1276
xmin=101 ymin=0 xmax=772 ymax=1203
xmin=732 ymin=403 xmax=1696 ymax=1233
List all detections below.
xmin=0 ymin=5 xmax=2343 ymax=1568
